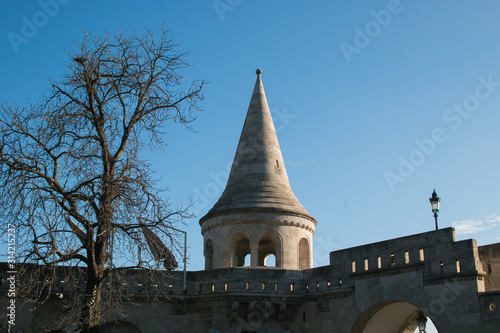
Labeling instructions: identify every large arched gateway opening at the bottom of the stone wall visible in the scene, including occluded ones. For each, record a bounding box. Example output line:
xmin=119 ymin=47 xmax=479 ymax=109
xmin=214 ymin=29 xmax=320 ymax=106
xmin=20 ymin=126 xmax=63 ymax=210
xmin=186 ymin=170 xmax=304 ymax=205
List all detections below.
xmin=351 ymin=301 xmax=438 ymax=333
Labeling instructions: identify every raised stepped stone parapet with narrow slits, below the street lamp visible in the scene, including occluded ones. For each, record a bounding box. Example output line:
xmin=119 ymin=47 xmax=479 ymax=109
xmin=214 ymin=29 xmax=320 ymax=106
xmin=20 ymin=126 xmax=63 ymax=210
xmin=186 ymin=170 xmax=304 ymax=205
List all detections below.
xmin=330 ymin=228 xmax=484 ymax=280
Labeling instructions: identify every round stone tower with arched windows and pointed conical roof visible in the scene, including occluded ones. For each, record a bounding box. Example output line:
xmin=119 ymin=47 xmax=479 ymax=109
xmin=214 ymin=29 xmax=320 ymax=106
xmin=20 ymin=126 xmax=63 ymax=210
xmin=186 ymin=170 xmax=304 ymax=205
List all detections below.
xmin=200 ymin=69 xmax=316 ymax=269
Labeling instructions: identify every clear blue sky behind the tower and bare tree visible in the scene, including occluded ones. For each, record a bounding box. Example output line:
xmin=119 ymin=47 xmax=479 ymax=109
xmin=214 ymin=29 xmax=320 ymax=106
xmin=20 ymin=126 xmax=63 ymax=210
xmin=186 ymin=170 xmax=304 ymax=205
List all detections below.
xmin=0 ymin=0 xmax=500 ymax=330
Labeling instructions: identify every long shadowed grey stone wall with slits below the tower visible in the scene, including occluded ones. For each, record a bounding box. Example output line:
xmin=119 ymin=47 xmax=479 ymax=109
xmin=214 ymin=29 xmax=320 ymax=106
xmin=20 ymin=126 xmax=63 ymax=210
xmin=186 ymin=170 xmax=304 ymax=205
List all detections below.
xmin=0 ymin=228 xmax=500 ymax=333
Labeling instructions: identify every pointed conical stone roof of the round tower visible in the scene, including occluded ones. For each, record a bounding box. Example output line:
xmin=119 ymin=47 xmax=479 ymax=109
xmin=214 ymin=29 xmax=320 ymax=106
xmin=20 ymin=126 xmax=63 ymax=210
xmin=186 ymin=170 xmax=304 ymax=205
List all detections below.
xmin=200 ymin=69 xmax=316 ymax=224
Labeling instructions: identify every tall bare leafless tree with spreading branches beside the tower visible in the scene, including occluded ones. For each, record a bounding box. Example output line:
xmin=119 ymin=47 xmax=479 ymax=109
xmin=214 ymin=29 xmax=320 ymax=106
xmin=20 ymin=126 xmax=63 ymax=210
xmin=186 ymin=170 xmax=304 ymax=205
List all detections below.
xmin=0 ymin=29 xmax=204 ymax=332
